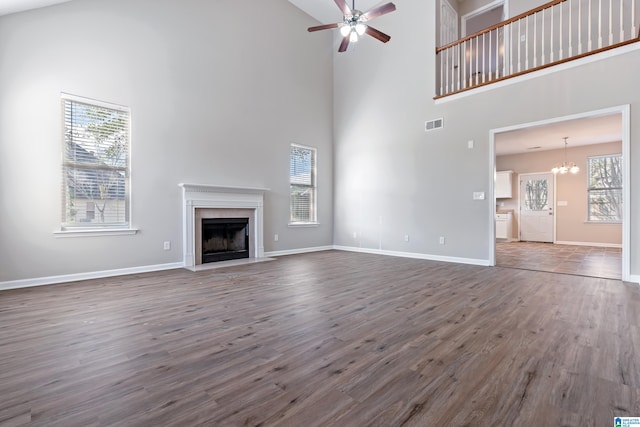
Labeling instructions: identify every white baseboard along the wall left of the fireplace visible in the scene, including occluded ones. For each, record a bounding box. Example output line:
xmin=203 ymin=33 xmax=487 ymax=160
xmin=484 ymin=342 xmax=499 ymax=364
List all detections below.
xmin=0 ymin=262 xmax=182 ymax=291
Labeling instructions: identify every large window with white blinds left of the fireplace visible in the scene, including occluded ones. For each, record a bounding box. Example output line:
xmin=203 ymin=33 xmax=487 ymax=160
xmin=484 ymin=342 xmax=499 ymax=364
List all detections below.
xmin=62 ymin=95 xmax=130 ymax=229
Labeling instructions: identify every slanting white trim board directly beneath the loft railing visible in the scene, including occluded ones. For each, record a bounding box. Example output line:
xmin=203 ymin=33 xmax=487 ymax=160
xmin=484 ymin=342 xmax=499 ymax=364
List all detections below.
xmin=434 ymin=43 xmax=640 ymax=105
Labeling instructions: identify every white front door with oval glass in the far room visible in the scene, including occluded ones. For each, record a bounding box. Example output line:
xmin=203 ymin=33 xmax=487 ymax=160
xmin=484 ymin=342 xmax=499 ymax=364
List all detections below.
xmin=520 ymin=173 xmax=554 ymax=243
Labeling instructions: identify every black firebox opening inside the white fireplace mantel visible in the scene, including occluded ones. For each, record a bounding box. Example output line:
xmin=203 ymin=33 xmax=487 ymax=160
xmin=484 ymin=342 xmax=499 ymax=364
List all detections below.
xmin=202 ymin=218 xmax=249 ymax=264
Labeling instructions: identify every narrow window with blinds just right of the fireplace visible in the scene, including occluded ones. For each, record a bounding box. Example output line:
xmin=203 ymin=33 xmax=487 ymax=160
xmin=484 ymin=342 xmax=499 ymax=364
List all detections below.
xmin=289 ymin=144 xmax=317 ymax=224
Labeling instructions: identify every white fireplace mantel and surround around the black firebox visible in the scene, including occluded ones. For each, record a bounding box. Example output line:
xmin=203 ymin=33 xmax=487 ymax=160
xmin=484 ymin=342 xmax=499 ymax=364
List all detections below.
xmin=179 ymin=183 xmax=268 ymax=269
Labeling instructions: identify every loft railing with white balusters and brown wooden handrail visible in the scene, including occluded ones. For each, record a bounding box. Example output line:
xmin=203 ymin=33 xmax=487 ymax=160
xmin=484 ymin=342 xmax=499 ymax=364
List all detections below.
xmin=435 ymin=0 xmax=640 ymax=99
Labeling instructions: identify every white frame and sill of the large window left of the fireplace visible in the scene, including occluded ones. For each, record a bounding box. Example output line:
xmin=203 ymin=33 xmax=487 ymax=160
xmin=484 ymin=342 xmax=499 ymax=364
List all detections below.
xmin=54 ymin=93 xmax=137 ymax=237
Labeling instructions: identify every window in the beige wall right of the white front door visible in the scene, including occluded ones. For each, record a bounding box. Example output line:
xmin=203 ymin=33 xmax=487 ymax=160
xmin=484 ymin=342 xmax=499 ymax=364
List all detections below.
xmin=587 ymin=154 xmax=622 ymax=222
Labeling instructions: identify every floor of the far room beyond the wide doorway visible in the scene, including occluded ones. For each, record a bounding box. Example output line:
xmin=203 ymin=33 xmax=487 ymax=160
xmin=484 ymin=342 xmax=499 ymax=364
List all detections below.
xmin=496 ymin=242 xmax=622 ymax=280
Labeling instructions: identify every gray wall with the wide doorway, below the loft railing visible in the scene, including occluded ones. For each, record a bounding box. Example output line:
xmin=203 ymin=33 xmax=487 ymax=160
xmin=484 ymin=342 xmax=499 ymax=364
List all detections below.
xmin=334 ymin=0 xmax=640 ymax=274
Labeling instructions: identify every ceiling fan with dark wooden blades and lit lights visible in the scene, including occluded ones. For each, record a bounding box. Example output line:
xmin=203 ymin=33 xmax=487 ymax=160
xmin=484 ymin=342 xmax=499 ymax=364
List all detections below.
xmin=307 ymin=0 xmax=396 ymax=52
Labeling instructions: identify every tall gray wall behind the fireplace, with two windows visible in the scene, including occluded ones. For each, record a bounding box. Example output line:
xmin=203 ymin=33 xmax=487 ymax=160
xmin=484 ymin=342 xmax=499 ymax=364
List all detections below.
xmin=0 ymin=0 xmax=333 ymax=282
